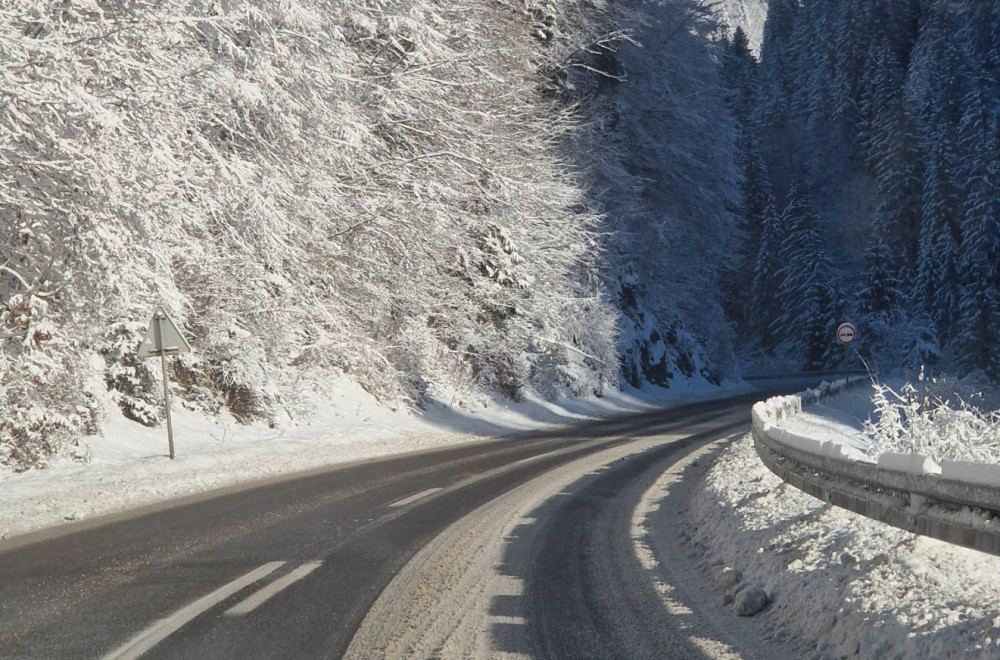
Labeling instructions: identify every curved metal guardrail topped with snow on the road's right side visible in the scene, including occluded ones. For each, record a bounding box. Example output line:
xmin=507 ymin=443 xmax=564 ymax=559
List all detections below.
xmin=753 ymin=381 xmax=1000 ymax=555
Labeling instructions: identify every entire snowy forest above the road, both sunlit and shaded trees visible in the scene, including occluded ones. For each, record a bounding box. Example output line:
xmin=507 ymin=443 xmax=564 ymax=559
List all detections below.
xmin=17 ymin=0 xmax=1000 ymax=469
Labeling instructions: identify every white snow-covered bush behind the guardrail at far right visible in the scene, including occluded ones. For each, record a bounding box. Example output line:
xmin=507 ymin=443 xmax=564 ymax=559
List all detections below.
xmin=865 ymin=373 xmax=1000 ymax=463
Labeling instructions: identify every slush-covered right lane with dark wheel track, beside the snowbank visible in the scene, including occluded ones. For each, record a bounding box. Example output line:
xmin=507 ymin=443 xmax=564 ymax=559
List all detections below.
xmin=347 ymin=400 xmax=792 ymax=660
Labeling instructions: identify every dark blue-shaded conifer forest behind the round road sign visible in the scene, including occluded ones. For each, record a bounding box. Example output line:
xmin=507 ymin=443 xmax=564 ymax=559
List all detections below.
xmin=723 ymin=0 xmax=1000 ymax=380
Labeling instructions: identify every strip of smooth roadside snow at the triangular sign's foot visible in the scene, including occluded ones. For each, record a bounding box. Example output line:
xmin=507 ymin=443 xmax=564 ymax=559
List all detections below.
xmin=0 ymin=380 xmax=751 ymax=541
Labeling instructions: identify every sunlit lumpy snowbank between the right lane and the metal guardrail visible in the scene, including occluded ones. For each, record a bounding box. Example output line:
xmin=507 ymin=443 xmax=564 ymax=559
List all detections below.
xmin=690 ymin=434 xmax=1000 ymax=660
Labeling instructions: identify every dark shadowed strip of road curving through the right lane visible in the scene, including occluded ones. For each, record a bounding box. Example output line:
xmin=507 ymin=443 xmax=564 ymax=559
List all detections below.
xmin=490 ymin=422 xmax=747 ymax=660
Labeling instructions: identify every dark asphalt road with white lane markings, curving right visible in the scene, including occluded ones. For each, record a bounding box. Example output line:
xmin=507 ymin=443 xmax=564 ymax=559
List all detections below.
xmin=0 ymin=382 xmax=824 ymax=660
